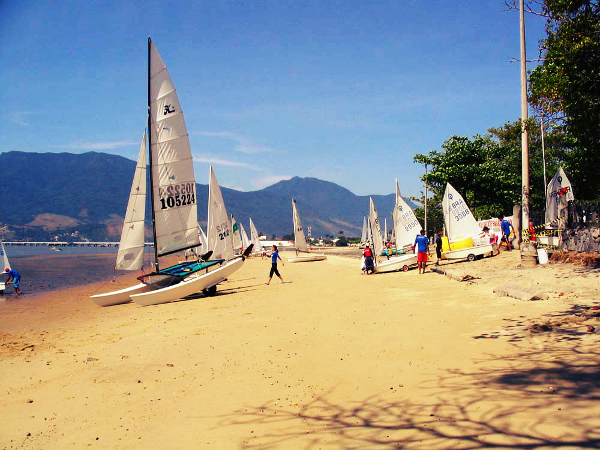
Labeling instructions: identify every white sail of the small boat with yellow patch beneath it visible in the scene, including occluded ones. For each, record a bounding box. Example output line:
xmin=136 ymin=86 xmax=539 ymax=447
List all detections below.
xmin=442 ymin=183 xmax=481 ymax=242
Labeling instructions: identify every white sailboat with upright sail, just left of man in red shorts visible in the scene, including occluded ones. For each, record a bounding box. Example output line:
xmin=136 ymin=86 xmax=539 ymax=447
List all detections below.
xmin=374 ymin=179 xmax=421 ymax=273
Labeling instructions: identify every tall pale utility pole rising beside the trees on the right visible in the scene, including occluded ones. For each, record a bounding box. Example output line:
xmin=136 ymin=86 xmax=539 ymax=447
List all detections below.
xmin=519 ymin=0 xmax=529 ymax=248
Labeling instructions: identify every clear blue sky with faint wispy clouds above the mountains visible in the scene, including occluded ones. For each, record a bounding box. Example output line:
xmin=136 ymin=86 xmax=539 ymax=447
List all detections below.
xmin=0 ymin=0 xmax=544 ymax=196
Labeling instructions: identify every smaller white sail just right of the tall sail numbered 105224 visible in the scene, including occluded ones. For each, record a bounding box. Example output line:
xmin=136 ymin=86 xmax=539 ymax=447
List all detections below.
xmin=206 ymin=166 xmax=233 ymax=260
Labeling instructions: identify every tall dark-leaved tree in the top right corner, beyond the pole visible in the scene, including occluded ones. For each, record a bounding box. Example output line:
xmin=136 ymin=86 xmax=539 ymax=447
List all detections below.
xmin=529 ymin=0 xmax=600 ymax=199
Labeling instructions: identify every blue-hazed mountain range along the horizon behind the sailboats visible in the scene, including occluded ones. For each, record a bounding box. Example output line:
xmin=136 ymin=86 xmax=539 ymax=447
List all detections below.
xmin=0 ymin=152 xmax=418 ymax=240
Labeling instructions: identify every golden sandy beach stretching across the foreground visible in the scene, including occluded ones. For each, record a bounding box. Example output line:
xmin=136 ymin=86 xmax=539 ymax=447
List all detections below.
xmin=0 ymin=252 xmax=600 ymax=449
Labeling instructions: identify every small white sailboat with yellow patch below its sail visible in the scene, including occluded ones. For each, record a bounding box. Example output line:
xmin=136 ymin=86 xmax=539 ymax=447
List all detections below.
xmin=442 ymin=183 xmax=494 ymax=261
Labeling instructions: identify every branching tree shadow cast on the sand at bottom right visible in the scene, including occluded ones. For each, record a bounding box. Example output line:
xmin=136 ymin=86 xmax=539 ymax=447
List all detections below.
xmin=219 ymin=336 xmax=600 ymax=450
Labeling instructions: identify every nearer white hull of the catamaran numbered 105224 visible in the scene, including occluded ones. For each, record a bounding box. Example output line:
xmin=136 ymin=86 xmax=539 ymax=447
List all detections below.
xmin=131 ymin=258 xmax=244 ymax=306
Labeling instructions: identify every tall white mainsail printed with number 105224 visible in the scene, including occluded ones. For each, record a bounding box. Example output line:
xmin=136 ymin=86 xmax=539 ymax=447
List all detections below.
xmin=149 ymin=42 xmax=200 ymax=256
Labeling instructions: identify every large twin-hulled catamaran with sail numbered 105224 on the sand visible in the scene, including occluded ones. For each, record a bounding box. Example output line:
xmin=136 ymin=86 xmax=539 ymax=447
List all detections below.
xmin=91 ymin=39 xmax=251 ymax=306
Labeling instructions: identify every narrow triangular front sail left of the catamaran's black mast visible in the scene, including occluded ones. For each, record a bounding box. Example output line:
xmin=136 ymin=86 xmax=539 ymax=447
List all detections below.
xmin=115 ymin=132 xmax=146 ymax=270
